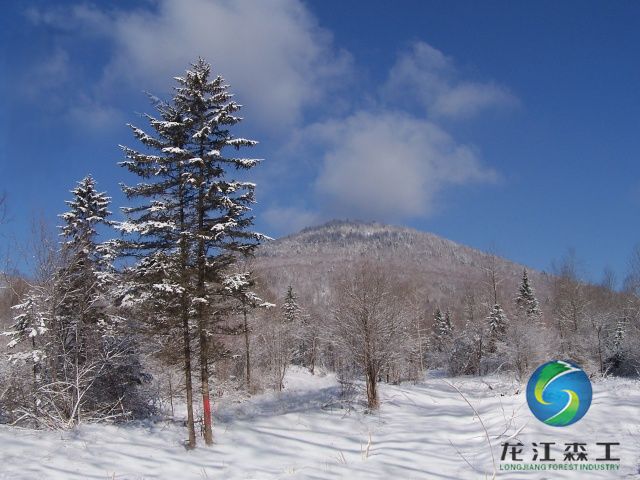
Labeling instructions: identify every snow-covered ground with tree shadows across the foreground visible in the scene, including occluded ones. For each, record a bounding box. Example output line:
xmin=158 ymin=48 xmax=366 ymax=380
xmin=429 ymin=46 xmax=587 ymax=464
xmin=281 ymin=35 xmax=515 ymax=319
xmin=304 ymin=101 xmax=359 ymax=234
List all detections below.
xmin=0 ymin=369 xmax=640 ymax=480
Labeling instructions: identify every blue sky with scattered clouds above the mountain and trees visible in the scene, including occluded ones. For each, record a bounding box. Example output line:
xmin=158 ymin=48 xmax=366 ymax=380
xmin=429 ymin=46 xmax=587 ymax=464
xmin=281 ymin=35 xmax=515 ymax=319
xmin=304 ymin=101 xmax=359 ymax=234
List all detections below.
xmin=0 ymin=0 xmax=640 ymax=280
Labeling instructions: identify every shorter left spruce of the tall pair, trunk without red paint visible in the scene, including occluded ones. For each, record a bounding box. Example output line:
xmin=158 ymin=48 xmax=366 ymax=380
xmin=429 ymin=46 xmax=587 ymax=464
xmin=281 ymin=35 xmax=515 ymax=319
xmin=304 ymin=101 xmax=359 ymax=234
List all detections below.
xmin=116 ymin=94 xmax=196 ymax=448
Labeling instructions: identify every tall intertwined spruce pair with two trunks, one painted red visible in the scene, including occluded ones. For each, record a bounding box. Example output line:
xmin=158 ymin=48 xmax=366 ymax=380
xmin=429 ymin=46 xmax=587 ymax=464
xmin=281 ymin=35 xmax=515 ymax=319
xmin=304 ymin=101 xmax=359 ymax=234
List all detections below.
xmin=120 ymin=59 xmax=266 ymax=447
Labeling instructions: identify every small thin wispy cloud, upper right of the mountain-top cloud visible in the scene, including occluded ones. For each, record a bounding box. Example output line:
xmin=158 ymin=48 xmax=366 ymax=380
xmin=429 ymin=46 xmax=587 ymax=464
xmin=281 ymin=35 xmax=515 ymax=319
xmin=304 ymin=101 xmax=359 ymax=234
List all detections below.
xmin=382 ymin=42 xmax=519 ymax=119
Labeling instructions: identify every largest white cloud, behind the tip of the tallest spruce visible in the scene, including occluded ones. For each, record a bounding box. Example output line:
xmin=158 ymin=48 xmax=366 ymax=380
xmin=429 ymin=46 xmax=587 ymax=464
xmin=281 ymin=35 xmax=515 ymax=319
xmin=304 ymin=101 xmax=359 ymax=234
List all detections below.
xmin=57 ymin=0 xmax=350 ymax=130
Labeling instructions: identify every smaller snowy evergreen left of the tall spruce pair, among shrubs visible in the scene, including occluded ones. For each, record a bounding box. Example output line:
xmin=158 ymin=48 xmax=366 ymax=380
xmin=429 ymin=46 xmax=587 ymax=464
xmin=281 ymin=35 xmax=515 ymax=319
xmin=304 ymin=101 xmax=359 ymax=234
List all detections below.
xmin=53 ymin=176 xmax=122 ymax=423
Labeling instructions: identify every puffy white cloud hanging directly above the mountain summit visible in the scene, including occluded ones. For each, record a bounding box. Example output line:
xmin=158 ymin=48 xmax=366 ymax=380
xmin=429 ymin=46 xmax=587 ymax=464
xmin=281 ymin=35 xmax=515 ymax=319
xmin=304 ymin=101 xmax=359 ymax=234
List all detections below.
xmin=304 ymin=111 xmax=498 ymax=220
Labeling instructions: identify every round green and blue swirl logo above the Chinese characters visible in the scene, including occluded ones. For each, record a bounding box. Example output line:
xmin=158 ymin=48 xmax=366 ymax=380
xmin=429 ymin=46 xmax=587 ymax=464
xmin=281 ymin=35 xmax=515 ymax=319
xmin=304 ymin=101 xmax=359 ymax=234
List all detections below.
xmin=527 ymin=360 xmax=593 ymax=427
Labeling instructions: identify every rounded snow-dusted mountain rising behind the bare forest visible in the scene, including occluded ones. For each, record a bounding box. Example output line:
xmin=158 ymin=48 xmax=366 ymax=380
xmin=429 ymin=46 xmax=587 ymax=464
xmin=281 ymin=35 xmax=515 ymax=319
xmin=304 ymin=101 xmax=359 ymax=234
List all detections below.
xmin=255 ymin=220 xmax=551 ymax=314
